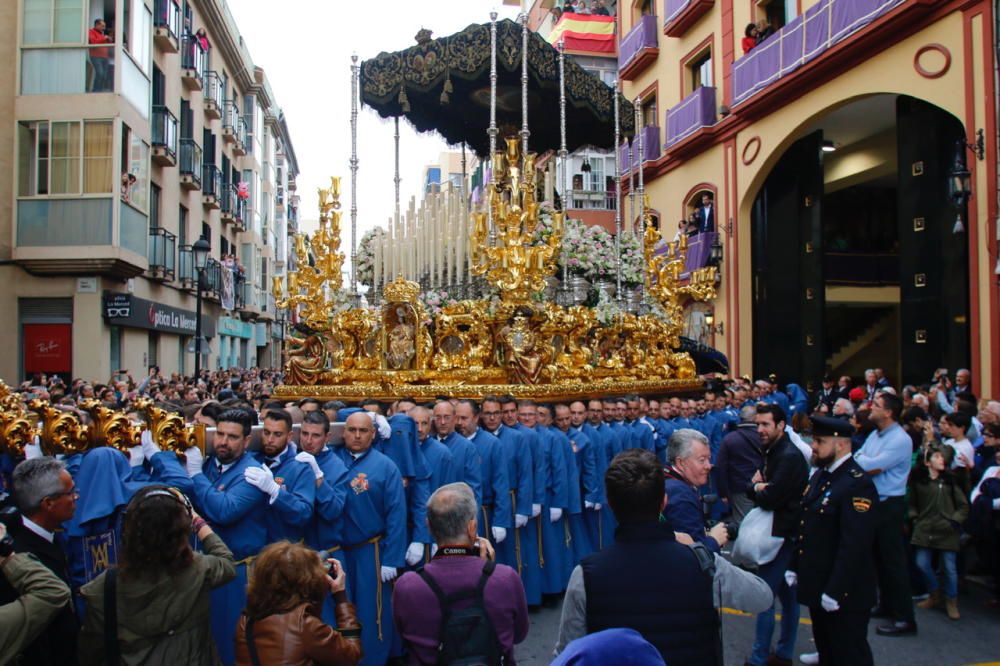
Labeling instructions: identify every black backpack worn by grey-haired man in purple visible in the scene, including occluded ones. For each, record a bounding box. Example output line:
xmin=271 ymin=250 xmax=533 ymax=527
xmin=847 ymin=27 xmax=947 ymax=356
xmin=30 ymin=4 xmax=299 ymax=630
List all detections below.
xmin=417 ymin=560 xmax=504 ymax=666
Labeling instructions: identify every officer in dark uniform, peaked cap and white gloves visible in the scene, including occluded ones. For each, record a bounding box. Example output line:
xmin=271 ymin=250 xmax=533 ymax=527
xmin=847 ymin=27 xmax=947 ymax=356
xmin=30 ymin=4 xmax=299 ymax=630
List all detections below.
xmin=785 ymin=416 xmax=878 ymax=666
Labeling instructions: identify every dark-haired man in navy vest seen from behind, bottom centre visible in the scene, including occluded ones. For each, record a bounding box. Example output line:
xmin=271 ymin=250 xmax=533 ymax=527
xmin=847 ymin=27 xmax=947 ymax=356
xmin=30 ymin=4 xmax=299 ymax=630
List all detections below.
xmin=556 ymin=449 xmax=722 ymax=666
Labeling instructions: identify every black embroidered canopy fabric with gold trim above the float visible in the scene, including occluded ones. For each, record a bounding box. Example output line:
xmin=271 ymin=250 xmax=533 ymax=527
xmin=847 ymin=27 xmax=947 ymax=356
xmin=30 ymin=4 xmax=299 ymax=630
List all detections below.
xmin=361 ymin=20 xmax=635 ymax=157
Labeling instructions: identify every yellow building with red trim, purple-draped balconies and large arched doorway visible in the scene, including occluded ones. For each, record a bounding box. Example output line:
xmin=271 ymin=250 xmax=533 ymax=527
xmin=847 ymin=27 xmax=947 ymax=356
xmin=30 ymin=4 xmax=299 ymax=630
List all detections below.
xmin=618 ymin=0 xmax=1000 ymax=396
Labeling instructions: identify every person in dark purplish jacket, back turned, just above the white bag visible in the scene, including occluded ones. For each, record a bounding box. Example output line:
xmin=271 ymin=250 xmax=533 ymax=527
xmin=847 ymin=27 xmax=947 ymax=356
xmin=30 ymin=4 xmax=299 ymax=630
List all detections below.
xmin=715 ymin=405 xmax=764 ymax=525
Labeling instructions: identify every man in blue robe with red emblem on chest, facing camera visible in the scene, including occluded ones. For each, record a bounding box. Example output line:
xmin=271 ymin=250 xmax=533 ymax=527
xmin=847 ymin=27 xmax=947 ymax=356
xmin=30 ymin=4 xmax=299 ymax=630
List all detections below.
xmin=336 ymin=412 xmax=406 ymax=666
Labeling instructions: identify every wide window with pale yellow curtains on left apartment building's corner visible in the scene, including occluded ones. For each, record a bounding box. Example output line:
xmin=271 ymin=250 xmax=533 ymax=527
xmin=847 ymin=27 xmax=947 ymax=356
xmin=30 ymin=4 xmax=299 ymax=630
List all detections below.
xmin=18 ymin=120 xmax=112 ymax=197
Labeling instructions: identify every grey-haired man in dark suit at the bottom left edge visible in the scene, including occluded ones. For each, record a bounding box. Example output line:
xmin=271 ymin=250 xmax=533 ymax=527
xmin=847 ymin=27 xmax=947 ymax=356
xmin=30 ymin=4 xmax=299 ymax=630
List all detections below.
xmin=0 ymin=457 xmax=80 ymax=666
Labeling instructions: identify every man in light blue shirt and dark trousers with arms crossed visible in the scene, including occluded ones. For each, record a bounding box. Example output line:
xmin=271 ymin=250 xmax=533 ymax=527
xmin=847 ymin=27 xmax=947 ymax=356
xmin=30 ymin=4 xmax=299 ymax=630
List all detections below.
xmin=854 ymin=392 xmax=917 ymax=636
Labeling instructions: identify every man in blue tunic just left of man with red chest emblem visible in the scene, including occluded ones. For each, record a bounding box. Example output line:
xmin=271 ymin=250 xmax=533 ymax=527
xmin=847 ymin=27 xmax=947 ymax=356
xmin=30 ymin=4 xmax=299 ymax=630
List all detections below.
xmin=295 ymin=411 xmax=347 ymax=626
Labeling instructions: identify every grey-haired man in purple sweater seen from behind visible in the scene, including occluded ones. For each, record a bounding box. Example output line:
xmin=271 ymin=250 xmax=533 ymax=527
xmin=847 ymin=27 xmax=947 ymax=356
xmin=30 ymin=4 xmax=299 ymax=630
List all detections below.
xmin=392 ymin=482 xmax=528 ymax=664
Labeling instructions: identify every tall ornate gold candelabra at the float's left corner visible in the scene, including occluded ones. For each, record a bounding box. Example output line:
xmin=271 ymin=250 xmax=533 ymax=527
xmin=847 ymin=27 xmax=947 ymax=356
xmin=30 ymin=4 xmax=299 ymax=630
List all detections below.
xmin=271 ymin=176 xmax=344 ymax=329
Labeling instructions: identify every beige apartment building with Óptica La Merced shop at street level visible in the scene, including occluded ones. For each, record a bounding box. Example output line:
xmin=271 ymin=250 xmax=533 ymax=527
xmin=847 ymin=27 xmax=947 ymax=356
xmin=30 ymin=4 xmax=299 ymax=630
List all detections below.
xmin=0 ymin=0 xmax=298 ymax=381
